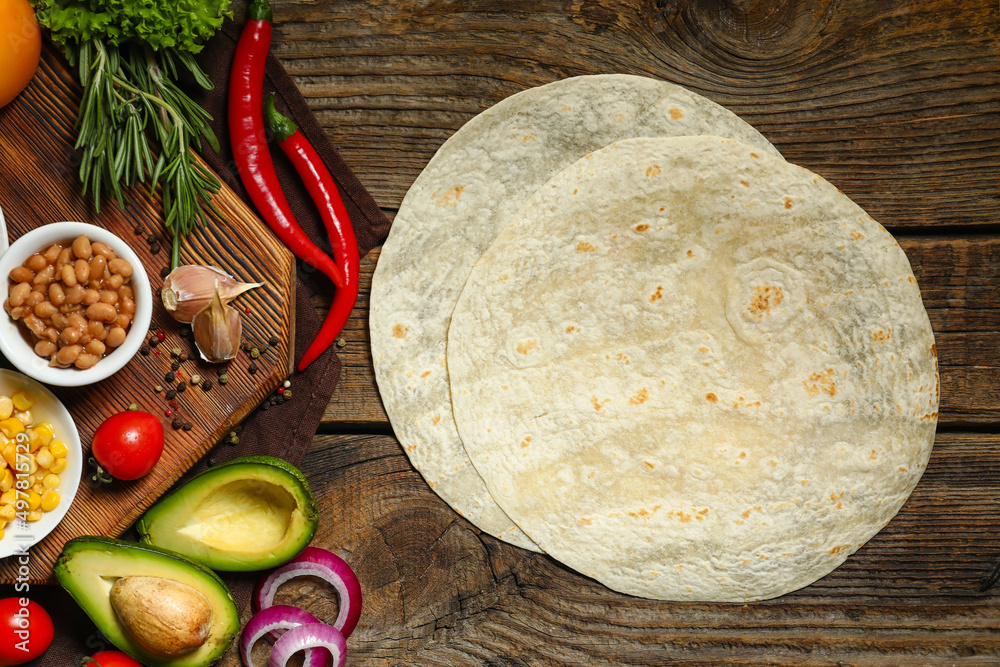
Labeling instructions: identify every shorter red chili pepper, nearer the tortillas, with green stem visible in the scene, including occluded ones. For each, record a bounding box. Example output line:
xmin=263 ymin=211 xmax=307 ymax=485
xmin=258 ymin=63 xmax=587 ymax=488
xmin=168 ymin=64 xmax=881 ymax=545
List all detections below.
xmin=264 ymin=95 xmax=361 ymax=371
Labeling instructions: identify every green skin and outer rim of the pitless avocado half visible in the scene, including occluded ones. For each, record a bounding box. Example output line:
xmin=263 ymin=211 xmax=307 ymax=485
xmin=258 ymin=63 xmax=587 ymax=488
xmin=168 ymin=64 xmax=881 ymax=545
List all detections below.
xmin=136 ymin=456 xmax=319 ymax=572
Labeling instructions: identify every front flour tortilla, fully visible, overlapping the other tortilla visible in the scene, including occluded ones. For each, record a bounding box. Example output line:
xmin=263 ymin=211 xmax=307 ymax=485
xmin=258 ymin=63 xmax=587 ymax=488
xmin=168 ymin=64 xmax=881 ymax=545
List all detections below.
xmin=448 ymin=137 xmax=938 ymax=602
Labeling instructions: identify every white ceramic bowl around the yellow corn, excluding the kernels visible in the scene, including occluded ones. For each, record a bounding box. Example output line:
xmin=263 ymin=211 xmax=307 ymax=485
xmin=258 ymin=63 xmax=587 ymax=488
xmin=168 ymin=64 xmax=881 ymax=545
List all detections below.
xmin=0 ymin=369 xmax=83 ymax=558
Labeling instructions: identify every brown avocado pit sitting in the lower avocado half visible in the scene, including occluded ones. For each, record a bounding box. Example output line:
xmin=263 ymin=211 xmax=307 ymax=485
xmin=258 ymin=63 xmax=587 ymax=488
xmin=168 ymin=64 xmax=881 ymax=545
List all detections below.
xmin=110 ymin=576 xmax=212 ymax=656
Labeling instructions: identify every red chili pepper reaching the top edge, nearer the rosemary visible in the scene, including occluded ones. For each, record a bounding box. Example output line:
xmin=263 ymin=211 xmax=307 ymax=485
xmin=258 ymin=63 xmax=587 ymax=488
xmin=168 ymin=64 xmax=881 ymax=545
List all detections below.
xmin=229 ymin=0 xmax=344 ymax=287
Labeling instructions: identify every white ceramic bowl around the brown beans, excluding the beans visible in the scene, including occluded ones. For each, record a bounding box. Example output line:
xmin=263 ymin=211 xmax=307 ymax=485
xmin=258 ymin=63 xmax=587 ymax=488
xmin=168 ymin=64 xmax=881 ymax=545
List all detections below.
xmin=0 ymin=222 xmax=153 ymax=387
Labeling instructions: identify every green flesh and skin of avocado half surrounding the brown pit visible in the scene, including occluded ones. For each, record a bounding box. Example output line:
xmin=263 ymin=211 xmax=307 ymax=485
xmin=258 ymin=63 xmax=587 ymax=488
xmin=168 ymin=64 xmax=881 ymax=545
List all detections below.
xmin=55 ymin=537 xmax=240 ymax=667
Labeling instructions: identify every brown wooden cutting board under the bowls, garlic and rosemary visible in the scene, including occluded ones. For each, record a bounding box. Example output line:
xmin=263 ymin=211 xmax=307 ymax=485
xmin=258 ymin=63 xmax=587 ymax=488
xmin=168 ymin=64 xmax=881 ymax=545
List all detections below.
xmin=0 ymin=45 xmax=295 ymax=583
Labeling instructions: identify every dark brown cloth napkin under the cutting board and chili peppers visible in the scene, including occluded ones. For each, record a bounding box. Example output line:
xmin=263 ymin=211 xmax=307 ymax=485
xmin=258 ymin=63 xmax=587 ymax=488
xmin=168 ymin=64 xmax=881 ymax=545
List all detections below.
xmin=11 ymin=21 xmax=390 ymax=667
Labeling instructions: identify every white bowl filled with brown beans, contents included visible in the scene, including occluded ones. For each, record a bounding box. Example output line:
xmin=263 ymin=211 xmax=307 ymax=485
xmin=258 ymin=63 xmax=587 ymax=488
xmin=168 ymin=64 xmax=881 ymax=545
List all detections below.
xmin=0 ymin=222 xmax=153 ymax=387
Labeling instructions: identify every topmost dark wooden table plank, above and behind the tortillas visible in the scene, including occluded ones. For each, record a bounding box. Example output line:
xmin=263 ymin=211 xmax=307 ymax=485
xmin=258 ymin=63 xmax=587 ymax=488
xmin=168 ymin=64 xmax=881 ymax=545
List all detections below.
xmin=264 ymin=0 xmax=1000 ymax=228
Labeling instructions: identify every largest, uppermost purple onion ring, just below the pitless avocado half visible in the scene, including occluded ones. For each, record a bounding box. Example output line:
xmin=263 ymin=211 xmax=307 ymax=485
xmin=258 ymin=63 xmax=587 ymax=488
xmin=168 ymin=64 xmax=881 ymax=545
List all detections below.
xmin=254 ymin=547 xmax=361 ymax=639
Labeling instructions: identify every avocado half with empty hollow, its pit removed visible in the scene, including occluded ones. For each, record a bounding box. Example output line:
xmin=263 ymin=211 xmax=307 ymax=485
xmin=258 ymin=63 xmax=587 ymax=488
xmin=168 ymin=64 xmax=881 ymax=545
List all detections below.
xmin=136 ymin=456 xmax=317 ymax=572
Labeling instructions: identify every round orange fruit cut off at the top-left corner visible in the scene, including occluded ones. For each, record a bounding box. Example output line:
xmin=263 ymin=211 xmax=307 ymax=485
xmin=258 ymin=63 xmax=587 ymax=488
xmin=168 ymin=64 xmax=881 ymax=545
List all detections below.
xmin=0 ymin=0 xmax=42 ymax=107
